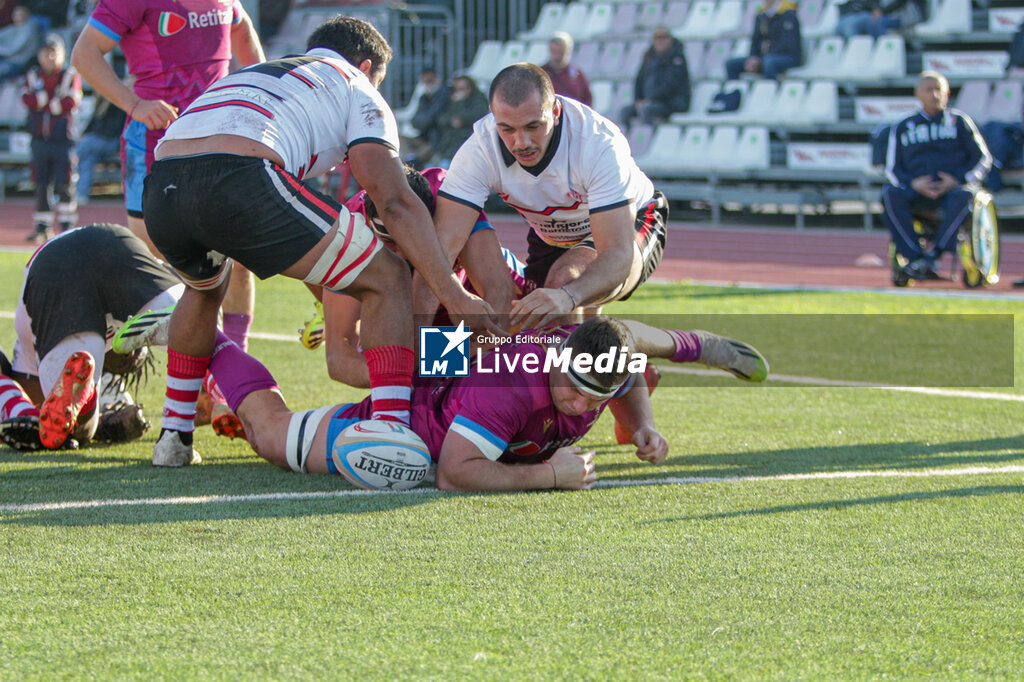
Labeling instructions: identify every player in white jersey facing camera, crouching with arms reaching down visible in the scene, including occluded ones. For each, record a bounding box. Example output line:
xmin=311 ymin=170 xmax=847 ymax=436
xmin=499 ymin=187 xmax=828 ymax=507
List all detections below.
xmin=414 ymin=59 xmax=668 ymax=329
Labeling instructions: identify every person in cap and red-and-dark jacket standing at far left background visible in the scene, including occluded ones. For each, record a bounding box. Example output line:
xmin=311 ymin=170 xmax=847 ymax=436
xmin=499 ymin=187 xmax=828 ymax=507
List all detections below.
xmin=22 ymin=34 xmax=82 ymax=242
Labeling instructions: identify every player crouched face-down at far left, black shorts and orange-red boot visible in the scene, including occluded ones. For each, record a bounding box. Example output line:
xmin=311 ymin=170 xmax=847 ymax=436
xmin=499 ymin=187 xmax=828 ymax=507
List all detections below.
xmin=0 ymin=224 xmax=184 ymax=450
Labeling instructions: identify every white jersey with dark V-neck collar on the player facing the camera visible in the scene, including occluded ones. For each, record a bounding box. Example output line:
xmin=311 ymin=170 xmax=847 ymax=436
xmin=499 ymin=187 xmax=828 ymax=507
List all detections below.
xmin=438 ymin=97 xmax=654 ymax=247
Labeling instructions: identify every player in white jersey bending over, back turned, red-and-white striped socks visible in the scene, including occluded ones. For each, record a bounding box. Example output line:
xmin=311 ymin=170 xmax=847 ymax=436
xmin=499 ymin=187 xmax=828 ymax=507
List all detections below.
xmin=142 ymin=15 xmax=495 ymax=466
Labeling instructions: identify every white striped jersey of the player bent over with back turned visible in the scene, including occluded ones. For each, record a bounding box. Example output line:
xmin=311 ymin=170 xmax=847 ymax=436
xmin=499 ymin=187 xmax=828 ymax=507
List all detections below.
xmin=157 ymin=48 xmax=398 ymax=179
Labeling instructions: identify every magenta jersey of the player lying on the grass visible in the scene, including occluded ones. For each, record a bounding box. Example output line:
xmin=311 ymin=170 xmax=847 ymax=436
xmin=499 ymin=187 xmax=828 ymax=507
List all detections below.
xmin=328 ymin=326 xmax=607 ymax=464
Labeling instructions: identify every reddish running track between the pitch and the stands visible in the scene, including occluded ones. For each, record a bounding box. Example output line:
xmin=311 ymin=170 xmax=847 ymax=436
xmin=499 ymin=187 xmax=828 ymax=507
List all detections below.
xmin=8 ymin=199 xmax=1024 ymax=296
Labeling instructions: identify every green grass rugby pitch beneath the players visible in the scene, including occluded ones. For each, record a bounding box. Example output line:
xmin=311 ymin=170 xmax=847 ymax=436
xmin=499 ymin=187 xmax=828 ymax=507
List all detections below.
xmin=0 ymin=254 xmax=1024 ymax=680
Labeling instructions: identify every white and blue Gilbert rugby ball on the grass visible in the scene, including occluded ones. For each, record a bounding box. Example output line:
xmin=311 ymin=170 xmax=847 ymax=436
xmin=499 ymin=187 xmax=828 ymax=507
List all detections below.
xmin=331 ymin=419 xmax=431 ymax=491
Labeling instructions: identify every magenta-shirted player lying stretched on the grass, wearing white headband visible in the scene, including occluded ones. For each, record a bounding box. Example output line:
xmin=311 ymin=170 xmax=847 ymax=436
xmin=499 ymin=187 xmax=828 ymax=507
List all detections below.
xmin=193 ymin=316 xmax=768 ymax=491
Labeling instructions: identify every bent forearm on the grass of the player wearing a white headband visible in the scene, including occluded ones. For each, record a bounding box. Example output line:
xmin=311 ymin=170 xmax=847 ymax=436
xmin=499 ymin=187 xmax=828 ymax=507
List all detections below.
xmin=436 ymin=430 xmax=597 ymax=491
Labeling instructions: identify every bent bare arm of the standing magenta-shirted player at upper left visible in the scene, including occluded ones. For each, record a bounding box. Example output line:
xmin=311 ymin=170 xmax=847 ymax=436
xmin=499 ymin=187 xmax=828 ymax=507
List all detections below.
xmin=71 ymin=26 xmax=178 ymax=130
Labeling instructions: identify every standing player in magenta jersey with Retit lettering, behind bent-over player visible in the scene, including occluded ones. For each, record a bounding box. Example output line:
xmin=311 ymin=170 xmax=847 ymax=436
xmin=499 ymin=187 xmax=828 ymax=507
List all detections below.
xmin=71 ymin=0 xmax=264 ymax=348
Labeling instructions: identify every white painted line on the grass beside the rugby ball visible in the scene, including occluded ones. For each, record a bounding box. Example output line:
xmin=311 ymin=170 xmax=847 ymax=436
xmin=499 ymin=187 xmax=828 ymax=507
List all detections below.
xmin=6 ymin=465 xmax=1024 ymax=513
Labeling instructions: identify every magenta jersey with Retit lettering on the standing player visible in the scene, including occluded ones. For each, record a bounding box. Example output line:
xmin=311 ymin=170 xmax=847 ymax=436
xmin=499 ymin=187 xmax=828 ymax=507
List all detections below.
xmin=89 ymin=0 xmax=245 ymax=112
